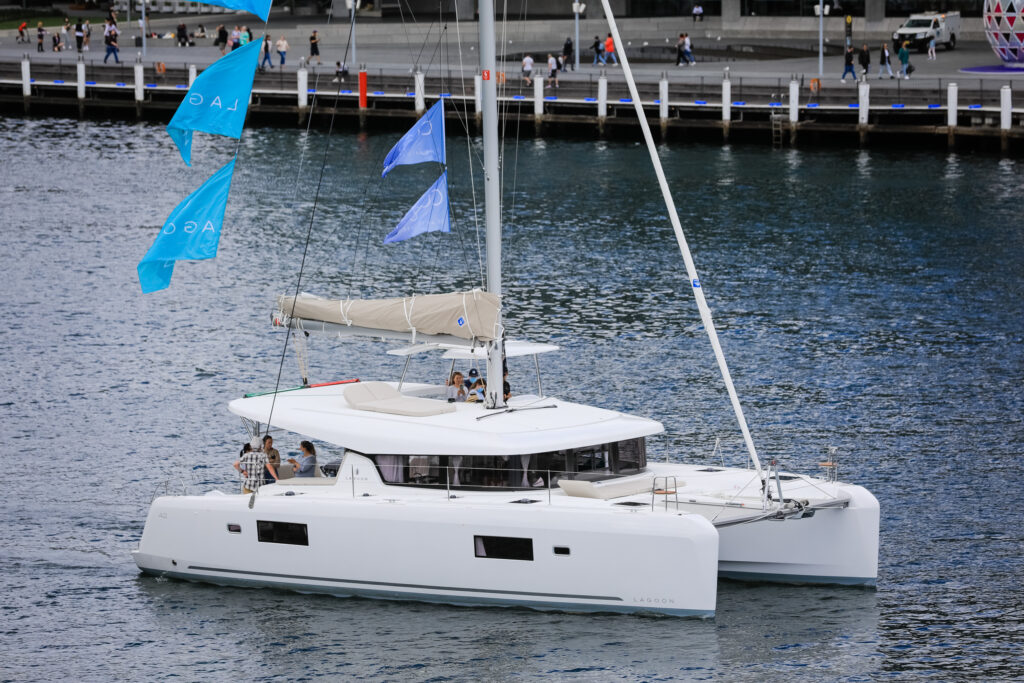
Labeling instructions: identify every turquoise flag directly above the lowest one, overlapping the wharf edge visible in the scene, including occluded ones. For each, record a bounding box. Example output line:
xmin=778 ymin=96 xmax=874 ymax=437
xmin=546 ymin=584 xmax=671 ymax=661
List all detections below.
xmin=167 ymin=39 xmax=263 ymax=166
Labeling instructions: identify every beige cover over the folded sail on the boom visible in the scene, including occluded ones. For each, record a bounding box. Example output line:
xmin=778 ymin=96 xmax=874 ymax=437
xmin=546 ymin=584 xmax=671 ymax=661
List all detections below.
xmin=278 ymin=290 xmax=502 ymax=341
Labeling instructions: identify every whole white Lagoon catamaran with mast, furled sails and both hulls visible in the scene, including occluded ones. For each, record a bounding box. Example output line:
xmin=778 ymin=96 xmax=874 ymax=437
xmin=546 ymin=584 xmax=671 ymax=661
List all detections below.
xmin=134 ymin=0 xmax=879 ymax=615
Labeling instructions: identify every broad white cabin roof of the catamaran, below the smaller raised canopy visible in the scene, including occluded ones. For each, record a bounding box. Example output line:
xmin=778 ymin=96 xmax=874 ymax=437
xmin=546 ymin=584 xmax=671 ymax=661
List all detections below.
xmin=227 ymin=382 xmax=665 ymax=456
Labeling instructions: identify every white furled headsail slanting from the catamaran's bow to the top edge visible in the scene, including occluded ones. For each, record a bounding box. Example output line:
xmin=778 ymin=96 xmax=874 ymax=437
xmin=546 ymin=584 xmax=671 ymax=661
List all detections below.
xmin=601 ymin=0 xmax=764 ymax=481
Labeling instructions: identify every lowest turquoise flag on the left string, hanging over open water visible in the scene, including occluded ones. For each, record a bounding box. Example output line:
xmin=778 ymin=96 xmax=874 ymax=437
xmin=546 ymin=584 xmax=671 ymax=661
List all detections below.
xmin=138 ymin=159 xmax=234 ymax=294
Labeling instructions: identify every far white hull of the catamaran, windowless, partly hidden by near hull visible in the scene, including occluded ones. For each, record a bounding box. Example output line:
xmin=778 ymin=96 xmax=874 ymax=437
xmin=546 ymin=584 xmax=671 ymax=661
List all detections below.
xmin=719 ymin=485 xmax=879 ymax=586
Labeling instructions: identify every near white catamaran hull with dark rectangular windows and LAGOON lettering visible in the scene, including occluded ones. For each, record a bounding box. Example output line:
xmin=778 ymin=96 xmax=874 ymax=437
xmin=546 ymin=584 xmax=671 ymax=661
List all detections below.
xmin=134 ymin=495 xmax=718 ymax=616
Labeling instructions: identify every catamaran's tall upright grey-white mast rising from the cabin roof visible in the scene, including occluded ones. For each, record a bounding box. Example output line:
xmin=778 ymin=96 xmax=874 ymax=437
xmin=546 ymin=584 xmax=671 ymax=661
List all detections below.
xmin=478 ymin=0 xmax=505 ymax=408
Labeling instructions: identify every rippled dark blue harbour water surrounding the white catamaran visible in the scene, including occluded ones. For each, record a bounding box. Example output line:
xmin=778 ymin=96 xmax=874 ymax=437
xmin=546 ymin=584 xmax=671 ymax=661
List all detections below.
xmin=0 ymin=114 xmax=1024 ymax=681
